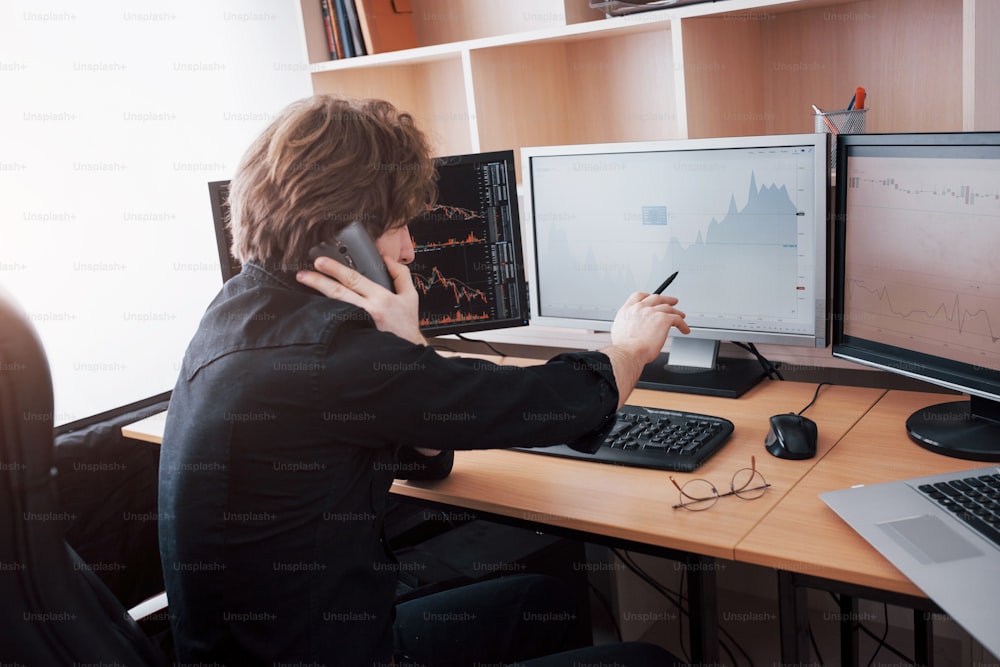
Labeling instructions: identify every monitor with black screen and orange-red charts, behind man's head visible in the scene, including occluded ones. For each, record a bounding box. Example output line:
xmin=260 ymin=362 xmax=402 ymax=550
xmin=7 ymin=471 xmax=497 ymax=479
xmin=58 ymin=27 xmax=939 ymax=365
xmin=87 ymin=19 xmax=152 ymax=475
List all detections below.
xmin=208 ymin=150 xmax=529 ymax=336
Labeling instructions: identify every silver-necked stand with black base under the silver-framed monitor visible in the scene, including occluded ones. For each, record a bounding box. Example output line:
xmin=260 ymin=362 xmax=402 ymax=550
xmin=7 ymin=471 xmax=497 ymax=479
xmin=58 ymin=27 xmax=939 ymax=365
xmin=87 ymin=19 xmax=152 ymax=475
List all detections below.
xmin=636 ymin=338 xmax=767 ymax=398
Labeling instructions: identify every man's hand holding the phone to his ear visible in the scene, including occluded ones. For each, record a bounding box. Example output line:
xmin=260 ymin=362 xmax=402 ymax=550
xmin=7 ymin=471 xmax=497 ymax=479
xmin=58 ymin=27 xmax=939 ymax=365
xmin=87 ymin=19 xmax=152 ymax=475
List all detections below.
xmin=295 ymin=256 xmax=427 ymax=345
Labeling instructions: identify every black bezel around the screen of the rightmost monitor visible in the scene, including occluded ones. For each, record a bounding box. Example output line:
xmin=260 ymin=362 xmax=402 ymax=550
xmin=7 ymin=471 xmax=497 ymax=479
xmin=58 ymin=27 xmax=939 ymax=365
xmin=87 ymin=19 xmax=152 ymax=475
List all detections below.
xmin=831 ymin=131 xmax=1000 ymax=401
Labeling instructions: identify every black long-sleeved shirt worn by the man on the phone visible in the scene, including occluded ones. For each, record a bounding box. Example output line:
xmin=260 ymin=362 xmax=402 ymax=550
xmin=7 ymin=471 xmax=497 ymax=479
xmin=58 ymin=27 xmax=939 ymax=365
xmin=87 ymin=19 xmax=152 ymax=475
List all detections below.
xmin=159 ymin=263 xmax=618 ymax=667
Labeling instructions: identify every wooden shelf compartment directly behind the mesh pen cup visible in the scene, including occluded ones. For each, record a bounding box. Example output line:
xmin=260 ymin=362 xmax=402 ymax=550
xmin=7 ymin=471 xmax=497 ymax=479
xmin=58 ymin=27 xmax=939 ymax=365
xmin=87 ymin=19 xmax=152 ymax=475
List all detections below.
xmin=679 ymin=0 xmax=963 ymax=137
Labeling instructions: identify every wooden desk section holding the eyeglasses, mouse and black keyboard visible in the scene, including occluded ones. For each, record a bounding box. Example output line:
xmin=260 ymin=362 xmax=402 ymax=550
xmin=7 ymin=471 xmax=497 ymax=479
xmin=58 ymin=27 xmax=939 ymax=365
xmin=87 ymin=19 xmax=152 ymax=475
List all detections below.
xmin=392 ymin=382 xmax=884 ymax=559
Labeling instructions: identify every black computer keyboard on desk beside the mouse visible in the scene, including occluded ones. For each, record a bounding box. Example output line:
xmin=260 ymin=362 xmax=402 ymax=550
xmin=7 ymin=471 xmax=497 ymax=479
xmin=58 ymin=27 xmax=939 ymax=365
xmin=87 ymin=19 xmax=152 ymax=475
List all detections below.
xmin=518 ymin=405 xmax=733 ymax=472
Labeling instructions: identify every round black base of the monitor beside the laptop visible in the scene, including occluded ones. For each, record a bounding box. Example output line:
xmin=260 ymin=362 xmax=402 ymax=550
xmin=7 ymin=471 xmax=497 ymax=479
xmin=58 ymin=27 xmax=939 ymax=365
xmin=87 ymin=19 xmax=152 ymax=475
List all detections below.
xmin=906 ymin=396 xmax=1000 ymax=461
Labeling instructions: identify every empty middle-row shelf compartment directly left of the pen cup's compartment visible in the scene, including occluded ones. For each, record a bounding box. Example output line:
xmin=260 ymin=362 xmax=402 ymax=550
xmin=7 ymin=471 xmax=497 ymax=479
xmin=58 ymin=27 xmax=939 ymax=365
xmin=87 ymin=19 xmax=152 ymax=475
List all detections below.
xmin=470 ymin=24 xmax=680 ymax=175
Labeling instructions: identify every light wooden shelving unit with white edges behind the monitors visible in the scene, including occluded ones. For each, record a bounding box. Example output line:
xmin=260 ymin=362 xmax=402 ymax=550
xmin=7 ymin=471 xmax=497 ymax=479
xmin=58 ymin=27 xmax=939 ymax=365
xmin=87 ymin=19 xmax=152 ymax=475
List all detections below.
xmin=292 ymin=0 xmax=1000 ymax=366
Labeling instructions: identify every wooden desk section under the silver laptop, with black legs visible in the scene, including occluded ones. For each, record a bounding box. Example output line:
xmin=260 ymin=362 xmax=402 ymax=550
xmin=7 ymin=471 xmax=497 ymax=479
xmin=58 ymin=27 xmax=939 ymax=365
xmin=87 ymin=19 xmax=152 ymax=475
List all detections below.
xmin=734 ymin=391 xmax=964 ymax=664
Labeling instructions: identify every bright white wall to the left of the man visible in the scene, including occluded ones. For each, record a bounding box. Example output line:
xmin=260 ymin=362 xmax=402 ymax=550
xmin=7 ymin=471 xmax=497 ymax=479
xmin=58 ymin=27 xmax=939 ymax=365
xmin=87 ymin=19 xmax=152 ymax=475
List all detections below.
xmin=0 ymin=0 xmax=311 ymax=424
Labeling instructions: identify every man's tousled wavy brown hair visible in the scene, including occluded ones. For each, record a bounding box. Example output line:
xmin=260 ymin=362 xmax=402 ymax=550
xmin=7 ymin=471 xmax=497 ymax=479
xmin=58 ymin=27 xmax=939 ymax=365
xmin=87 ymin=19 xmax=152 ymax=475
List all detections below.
xmin=229 ymin=95 xmax=437 ymax=270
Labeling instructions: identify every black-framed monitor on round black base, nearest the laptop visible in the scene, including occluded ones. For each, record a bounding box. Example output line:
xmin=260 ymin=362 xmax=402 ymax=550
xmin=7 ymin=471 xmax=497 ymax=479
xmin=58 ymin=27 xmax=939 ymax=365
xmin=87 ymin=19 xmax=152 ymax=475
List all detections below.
xmin=833 ymin=132 xmax=1000 ymax=461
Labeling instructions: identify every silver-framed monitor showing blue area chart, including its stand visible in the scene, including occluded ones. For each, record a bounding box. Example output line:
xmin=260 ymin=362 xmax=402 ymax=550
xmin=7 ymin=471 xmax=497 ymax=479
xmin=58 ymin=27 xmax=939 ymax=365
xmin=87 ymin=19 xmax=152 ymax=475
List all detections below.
xmin=521 ymin=133 xmax=829 ymax=397
